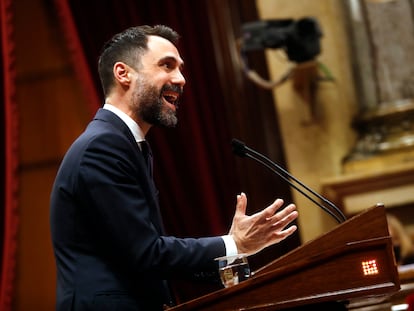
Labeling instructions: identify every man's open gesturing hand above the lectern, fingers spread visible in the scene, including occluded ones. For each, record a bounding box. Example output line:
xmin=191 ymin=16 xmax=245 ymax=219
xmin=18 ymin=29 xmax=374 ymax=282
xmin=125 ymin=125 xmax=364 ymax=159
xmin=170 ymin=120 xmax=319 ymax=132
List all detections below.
xmin=229 ymin=193 xmax=298 ymax=255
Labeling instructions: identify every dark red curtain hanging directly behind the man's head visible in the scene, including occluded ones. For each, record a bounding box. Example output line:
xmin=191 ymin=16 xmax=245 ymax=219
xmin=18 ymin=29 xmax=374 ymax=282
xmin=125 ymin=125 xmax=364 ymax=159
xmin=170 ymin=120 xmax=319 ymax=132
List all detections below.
xmin=56 ymin=0 xmax=240 ymax=240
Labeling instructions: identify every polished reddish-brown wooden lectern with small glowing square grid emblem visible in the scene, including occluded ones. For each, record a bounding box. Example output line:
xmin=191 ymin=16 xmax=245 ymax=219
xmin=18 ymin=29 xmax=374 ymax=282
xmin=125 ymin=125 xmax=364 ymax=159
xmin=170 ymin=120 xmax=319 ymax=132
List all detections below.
xmin=168 ymin=204 xmax=400 ymax=311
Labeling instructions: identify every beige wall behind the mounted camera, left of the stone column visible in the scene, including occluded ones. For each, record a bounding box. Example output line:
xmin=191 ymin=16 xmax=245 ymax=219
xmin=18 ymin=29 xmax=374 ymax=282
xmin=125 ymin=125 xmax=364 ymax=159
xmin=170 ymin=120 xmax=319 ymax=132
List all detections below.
xmin=257 ymin=0 xmax=357 ymax=241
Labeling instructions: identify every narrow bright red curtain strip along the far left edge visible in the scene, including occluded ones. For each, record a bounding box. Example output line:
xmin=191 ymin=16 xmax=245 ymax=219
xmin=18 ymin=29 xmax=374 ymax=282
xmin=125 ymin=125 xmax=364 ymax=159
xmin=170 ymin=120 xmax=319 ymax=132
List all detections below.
xmin=0 ymin=0 xmax=19 ymax=311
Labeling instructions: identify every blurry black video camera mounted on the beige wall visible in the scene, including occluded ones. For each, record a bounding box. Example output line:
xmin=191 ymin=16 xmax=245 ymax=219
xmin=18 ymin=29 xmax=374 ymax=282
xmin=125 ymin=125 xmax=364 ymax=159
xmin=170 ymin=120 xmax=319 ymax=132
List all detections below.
xmin=241 ymin=17 xmax=322 ymax=63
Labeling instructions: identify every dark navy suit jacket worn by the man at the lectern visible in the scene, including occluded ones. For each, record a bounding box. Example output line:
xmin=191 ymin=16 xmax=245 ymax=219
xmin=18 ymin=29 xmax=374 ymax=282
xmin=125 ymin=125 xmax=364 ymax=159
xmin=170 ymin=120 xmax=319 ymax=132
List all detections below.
xmin=50 ymin=109 xmax=225 ymax=311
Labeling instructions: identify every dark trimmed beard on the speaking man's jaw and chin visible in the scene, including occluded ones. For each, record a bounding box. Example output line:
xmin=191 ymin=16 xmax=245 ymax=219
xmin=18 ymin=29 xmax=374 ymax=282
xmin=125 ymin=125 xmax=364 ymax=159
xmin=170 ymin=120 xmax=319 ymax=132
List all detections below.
xmin=132 ymin=81 xmax=178 ymax=127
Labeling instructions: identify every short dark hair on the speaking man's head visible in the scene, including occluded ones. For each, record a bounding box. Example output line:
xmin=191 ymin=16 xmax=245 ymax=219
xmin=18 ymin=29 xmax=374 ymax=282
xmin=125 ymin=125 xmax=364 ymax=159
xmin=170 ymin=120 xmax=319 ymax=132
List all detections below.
xmin=98 ymin=25 xmax=179 ymax=96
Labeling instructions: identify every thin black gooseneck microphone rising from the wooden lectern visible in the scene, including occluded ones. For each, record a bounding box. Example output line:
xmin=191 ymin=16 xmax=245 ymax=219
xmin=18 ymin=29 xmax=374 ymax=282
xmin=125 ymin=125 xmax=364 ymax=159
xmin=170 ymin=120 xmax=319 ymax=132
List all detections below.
xmin=231 ymin=138 xmax=346 ymax=223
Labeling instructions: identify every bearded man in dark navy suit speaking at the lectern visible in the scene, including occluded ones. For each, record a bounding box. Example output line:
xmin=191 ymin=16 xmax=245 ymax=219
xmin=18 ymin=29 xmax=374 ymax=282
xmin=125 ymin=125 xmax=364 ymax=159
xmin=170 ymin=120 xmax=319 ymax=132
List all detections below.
xmin=51 ymin=26 xmax=297 ymax=310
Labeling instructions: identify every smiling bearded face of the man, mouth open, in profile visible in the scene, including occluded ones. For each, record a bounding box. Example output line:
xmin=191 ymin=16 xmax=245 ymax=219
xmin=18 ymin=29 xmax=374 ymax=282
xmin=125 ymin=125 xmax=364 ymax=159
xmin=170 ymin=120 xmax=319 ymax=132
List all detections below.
xmin=132 ymin=36 xmax=185 ymax=127
